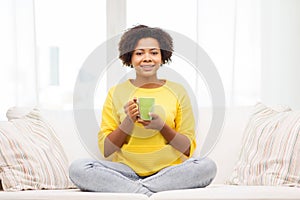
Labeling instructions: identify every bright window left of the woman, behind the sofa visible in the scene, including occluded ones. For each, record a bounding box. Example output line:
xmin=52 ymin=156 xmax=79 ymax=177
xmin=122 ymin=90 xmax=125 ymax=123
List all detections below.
xmin=35 ymin=0 xmax=106 ymax=108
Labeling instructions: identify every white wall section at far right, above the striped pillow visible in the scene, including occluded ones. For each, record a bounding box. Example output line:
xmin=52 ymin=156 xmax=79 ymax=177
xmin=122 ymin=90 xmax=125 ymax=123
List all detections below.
xmin=261 ymin=0 xmax=300 ymax=109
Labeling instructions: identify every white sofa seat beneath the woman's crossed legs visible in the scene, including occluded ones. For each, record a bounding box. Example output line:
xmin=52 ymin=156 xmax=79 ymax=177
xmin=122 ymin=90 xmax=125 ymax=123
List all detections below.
xmin=0 ymin=185 xmax=300 ymax=200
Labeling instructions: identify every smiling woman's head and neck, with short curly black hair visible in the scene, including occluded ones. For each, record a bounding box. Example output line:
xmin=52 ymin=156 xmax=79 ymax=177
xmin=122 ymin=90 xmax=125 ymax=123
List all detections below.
xmin=119 ymin=25 xmax=173 ymax=88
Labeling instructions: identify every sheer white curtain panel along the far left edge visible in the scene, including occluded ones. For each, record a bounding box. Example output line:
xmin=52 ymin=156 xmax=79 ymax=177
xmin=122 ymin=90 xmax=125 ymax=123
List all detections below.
xmin=0 ymin=0 xmax=38 ymax=120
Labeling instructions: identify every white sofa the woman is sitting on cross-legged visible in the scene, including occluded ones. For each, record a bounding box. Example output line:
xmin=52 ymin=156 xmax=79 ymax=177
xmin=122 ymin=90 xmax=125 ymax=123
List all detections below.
xmin=0 ymin=107 xmax=300 ymax=200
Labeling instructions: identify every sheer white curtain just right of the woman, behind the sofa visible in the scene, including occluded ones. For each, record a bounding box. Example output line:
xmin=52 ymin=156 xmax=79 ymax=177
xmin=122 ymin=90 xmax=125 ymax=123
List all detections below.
xmin=198 ymin=0 xmax=261 ymax=106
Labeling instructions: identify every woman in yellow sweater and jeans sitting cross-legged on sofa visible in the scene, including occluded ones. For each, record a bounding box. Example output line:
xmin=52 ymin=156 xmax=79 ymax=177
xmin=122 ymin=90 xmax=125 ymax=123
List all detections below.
xmin=70 ymin=25 xmax=216 ymax=196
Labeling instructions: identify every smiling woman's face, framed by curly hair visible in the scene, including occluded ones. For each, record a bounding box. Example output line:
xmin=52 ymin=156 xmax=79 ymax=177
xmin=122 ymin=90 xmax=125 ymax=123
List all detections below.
xmin=131 ymin=38 xmax=162 ymax=77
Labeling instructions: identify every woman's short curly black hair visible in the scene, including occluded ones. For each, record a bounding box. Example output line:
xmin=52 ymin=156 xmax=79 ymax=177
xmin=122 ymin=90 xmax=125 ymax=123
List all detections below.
xmin=119 ymin=25 xmax=173 ymax=67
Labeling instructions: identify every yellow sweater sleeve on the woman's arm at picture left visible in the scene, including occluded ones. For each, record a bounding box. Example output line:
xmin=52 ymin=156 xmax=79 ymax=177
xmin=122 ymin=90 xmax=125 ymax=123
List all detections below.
xmin=98 ymin=88 xmax=120 ymax=155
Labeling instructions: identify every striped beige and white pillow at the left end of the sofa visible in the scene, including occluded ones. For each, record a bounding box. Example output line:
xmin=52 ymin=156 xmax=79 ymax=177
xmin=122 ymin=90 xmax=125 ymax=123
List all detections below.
xmin=0 ymin=109 xmax=74 ymax=191
